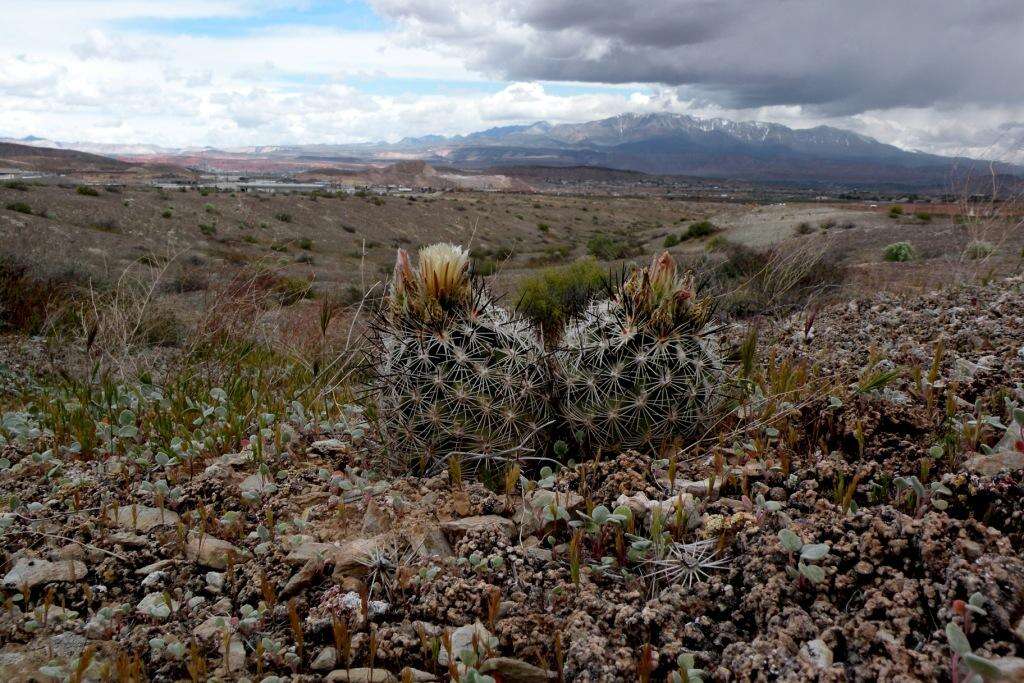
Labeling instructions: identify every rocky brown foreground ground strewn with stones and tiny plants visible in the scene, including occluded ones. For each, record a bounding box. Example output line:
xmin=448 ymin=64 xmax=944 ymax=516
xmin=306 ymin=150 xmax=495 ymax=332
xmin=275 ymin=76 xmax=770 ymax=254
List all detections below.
xmin=0 ymin=279 xmax=1024 ymax=683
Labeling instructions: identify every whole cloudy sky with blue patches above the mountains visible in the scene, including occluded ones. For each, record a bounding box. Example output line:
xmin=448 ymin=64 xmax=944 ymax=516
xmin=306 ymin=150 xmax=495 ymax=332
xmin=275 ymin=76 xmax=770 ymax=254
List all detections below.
xmin=0 ymin=0 xmax=1024 ymax=161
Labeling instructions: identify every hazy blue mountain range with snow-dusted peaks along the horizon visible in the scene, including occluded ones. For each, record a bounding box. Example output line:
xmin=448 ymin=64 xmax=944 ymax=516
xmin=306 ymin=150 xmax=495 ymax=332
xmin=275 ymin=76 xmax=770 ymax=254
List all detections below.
xmin=4 ymin=114 xmax=1024 ymax=186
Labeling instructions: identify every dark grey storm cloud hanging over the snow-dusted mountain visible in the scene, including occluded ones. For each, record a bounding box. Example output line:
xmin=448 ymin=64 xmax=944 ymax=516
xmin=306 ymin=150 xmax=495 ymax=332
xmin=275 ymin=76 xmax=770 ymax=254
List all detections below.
xmin=377 ymin=0 xmax=1024 ymax=115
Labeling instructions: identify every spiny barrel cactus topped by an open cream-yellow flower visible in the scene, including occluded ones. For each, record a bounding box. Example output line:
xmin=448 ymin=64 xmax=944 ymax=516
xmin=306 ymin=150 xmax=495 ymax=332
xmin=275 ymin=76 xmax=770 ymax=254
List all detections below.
xmin=373 ymin=244 xmax=549 ymax=472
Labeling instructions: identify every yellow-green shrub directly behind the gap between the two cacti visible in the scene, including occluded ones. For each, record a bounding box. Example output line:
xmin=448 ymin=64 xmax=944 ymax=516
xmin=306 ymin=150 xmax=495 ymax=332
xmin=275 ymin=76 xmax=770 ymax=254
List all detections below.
xmin=516 ymin=258 xmax=607 ymax=339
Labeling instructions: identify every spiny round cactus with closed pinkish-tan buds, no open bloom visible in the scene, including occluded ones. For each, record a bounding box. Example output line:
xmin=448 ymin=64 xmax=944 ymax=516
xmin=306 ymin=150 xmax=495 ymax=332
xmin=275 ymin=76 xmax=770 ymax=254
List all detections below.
xmin=556 ymin=252 xmax=724 ymax=449
